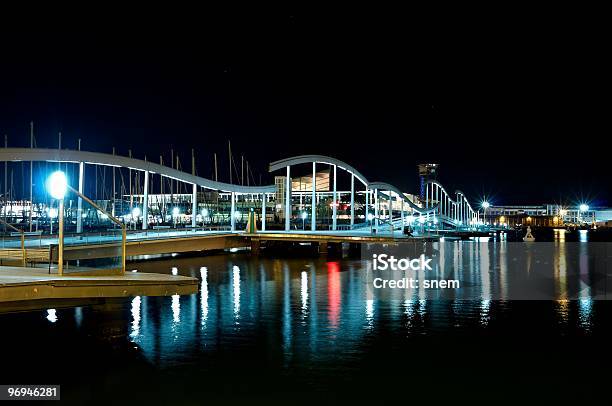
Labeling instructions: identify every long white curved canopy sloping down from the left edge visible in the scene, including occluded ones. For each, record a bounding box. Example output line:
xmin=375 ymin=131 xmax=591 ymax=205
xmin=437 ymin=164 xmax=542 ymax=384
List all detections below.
xmin=0 ymin=148 xmax=276 ymax=193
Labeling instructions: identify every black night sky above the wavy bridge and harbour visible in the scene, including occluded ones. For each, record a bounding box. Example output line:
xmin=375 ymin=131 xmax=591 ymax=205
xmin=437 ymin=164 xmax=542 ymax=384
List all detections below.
xmin=0 ymin=12 xmax=612 ymax=204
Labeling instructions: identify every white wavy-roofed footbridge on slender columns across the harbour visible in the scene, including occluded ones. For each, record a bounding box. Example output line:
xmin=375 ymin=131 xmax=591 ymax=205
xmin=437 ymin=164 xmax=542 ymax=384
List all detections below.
xmin=0 ymin=148 xmax=482 ymax=266
